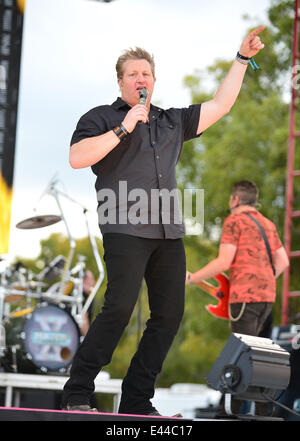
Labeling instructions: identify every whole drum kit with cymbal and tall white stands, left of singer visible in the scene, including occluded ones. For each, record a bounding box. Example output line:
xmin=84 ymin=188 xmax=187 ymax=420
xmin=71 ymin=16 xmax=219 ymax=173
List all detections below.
xmin=0 ymin=180 xmax=104 ymax=375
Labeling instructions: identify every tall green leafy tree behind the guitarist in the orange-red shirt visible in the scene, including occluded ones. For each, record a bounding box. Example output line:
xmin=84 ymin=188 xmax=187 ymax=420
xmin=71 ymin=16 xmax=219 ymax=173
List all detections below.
xmin=178 ymin=12 xmax=300 ymax=330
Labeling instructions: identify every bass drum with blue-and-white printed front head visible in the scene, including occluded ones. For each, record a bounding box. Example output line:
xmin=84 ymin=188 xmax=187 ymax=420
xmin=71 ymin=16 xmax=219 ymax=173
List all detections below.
xmin=3 ymin=305 xmax=80 ymax=373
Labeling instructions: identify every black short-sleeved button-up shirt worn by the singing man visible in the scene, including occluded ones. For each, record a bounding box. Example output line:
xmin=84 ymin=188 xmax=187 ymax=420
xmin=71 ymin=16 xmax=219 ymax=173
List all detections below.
xmin=71 ymin=98 xmax=201 ymax=239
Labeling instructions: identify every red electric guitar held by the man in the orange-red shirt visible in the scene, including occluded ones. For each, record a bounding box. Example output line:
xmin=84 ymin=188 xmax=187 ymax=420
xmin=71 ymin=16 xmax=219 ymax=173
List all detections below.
xmin=195 ymin=273 xmax=229 ymax=320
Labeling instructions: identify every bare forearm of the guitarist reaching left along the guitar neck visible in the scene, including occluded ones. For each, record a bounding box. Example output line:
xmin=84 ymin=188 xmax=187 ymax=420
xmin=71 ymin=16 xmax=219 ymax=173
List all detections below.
xmin=186 ymin=243 xmax=236 ymax=283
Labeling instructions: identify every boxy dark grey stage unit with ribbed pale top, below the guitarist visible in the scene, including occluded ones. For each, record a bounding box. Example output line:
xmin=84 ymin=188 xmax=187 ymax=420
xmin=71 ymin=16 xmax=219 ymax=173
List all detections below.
xmin=207 ymin=334 xmax=290 ymax=402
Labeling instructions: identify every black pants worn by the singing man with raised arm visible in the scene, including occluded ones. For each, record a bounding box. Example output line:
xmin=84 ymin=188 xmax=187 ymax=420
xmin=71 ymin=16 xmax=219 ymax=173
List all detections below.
xmin=62 ymin=233 xmax=186 ymax=413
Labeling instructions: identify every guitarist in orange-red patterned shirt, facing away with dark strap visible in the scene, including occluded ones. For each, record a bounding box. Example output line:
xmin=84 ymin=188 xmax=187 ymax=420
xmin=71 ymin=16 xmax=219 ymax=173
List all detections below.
xmin=186 ymin=181 xmax=289 ymax=336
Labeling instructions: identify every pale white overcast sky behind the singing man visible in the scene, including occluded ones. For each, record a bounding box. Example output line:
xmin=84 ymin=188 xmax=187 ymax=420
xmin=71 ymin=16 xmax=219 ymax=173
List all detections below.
xmin=8 ymin=0 xmax=271 ymax=259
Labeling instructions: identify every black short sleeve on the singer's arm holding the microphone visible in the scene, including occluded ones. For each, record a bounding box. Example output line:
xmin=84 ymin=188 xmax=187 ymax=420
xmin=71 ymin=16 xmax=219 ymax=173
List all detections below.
xmin=70 ymin=109 xmax=106 ymax=146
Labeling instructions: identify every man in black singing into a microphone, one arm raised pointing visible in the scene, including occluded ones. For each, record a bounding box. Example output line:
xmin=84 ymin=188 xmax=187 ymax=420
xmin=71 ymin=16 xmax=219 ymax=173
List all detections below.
xmin=62 ymin=27 xmax=264 ymax=415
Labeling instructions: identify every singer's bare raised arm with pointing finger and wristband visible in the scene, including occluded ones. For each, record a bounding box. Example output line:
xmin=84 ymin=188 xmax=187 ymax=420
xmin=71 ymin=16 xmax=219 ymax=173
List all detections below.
xmin=197 ymin=26 xmax=265 ymax=134
